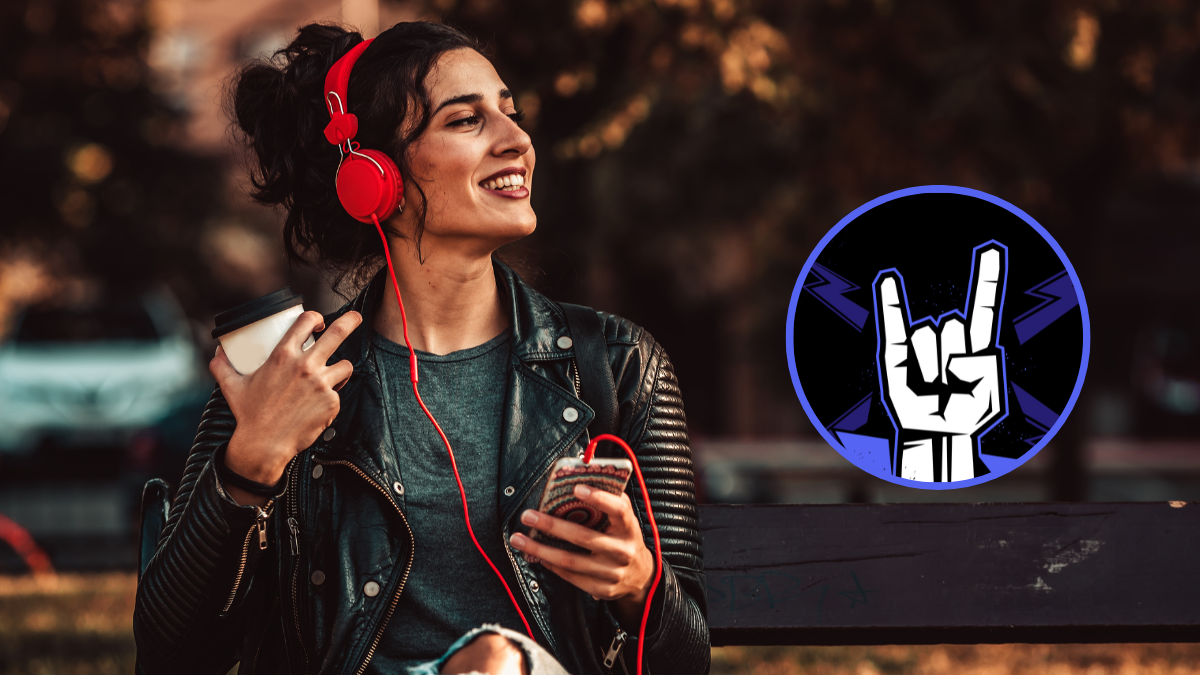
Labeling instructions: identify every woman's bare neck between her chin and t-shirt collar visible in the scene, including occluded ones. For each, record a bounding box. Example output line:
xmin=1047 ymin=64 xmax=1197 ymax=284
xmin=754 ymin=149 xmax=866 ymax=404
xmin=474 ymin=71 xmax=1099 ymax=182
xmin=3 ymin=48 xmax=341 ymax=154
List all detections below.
xmin=373 ymin=238 xmax=509 ymax=354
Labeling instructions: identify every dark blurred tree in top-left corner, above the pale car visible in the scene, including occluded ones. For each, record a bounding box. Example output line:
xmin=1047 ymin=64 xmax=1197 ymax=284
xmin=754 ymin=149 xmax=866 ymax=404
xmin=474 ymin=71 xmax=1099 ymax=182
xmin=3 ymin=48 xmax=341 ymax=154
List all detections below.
xmin=0 ymin=0 xmax=222 ymax=312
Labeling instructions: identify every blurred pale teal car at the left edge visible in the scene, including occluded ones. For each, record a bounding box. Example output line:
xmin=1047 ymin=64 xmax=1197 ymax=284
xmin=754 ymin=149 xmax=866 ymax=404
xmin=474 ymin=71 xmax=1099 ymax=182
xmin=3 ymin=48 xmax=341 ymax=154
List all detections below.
xmin=0 ymin=289 xmax=202 ymax=454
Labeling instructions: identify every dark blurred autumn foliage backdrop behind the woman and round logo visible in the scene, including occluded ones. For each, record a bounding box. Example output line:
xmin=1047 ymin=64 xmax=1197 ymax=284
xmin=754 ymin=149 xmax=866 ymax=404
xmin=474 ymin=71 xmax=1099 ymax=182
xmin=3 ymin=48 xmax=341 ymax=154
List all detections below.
xmin=7 ymin=0 xmax=1200 ymax=478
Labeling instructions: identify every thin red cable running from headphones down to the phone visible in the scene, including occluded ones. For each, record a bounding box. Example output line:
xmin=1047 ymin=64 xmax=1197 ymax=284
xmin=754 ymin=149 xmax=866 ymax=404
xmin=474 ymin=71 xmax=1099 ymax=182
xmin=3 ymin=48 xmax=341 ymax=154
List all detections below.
xmin=371 ymin=215 xmax=662 ymax=674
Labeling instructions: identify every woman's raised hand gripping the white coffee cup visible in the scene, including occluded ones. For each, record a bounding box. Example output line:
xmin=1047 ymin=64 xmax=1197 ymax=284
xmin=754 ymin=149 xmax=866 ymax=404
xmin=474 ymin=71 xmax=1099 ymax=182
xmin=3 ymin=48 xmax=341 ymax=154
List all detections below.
xmin=209 ymin=311 xmax=362 ymax=504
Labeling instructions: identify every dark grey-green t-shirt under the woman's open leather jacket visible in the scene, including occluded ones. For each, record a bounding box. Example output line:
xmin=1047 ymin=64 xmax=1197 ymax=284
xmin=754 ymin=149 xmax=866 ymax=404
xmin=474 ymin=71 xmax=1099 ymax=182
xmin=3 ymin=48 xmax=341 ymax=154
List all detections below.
xmin=370 ymin=331 xmax=524 ymax=675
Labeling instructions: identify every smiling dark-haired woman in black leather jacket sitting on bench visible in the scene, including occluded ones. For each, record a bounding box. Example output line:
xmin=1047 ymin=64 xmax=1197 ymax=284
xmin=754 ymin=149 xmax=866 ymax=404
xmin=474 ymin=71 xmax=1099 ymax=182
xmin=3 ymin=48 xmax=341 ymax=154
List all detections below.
xmin=134 ymin=22 xmax=709 ymax=675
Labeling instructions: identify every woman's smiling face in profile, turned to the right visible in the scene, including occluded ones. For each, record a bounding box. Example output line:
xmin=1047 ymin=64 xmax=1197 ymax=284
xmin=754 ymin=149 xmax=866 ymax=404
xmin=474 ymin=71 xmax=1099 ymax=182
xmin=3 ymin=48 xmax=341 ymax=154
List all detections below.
xmin=401 ymin=49 xmax=538 ymax=255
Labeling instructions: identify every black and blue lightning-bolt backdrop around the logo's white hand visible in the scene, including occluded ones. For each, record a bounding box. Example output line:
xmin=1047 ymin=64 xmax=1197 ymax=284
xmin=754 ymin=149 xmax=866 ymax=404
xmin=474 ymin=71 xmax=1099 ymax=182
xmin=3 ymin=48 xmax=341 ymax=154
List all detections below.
xmin=788 ymin=186 xmax=1090 ymax=489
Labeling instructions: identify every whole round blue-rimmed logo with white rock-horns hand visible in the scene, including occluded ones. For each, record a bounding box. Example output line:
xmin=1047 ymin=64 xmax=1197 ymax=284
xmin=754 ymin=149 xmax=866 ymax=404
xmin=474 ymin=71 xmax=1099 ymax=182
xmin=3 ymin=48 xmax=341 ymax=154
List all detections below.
xmin=787 ymin=185 xmax=1091 ymax=490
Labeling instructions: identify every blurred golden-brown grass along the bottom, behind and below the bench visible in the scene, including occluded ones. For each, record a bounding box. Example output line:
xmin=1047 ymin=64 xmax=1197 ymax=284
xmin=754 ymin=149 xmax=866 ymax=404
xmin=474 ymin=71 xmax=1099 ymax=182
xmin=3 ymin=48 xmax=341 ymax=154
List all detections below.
xmin=0 ymin=574 xmax=1200 ymax=675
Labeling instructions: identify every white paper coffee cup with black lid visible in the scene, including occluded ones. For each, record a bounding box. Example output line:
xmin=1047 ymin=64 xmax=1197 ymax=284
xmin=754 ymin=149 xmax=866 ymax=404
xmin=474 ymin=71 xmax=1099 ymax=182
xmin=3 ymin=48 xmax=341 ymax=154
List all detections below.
xmin=212 ymin=287 xmax=317 ymax=375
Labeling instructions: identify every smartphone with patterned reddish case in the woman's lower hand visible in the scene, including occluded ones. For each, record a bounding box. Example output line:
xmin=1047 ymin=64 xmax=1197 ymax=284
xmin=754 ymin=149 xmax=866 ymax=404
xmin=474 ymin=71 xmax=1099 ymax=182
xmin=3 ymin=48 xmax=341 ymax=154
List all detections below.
xmin=526 ymin=458 xmax=634 ymax=562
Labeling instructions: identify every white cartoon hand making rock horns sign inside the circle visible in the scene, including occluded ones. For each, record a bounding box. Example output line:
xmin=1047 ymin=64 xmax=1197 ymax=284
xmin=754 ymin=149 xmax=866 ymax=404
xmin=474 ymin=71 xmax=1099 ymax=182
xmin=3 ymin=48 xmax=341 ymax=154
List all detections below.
xmin=875 ymin=241 xmax=1008 ymax=482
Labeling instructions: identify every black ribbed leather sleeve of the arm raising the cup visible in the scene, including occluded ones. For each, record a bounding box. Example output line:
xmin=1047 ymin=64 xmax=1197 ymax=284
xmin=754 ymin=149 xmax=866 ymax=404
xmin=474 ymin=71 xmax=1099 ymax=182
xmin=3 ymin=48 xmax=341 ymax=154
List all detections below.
xmin=133 ymin=389 xmax=272 ymax=675
